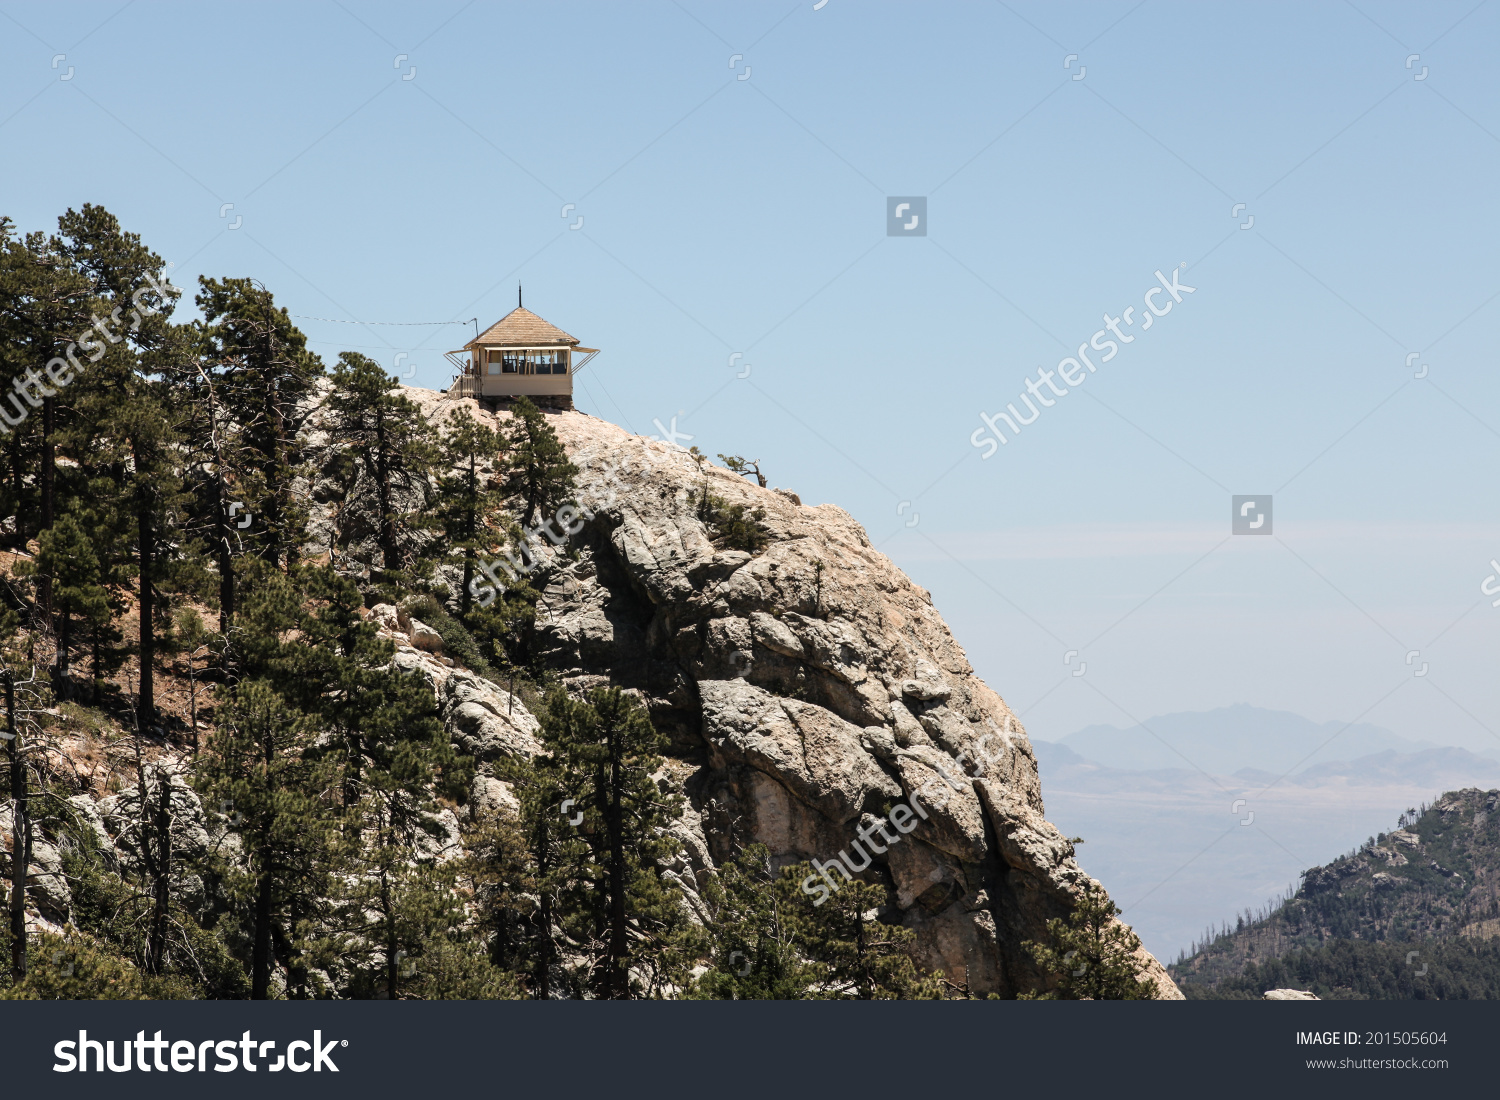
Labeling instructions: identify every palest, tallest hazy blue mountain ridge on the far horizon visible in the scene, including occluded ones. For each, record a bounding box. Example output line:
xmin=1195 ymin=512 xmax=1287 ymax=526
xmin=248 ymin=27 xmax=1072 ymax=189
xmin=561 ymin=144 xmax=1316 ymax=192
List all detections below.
xmin=1061 ymin=704 xmax=1439 ymax=776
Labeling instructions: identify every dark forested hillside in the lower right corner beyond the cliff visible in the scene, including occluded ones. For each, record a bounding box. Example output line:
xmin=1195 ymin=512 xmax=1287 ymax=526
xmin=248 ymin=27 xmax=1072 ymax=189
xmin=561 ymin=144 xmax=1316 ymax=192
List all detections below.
xmin=1169 ymin=788 xmax=1500 ymax=999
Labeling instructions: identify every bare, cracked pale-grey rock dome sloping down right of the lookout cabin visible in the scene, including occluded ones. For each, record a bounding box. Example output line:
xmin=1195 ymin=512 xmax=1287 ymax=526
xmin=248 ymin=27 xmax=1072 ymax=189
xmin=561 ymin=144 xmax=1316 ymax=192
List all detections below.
xmin=398 ymin=390 xmax=1182 ymax=998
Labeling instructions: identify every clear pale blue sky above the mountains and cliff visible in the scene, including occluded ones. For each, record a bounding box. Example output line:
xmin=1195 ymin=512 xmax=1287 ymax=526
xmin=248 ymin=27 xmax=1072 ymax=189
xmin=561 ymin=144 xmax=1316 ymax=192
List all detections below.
xmin=0 ymin=0 xmax=1500 ymax=774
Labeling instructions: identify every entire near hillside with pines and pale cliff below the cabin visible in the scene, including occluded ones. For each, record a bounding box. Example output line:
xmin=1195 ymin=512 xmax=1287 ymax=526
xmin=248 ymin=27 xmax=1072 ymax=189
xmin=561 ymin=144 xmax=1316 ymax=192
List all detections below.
xmin=0 ymin=206 xmax=1181 ymax=999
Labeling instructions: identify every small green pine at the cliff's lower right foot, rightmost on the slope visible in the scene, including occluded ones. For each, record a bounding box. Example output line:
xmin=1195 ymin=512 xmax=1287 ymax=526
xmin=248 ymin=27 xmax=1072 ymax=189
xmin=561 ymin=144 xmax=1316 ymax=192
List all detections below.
xmin=1022 ymin=879 xmax=1157 ymax=1001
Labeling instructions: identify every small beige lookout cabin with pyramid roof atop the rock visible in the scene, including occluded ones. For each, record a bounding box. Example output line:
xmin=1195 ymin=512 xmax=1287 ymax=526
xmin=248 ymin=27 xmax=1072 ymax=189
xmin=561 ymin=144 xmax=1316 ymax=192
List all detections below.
xmin=447 ymin=306 xmax=599 ymax=408
